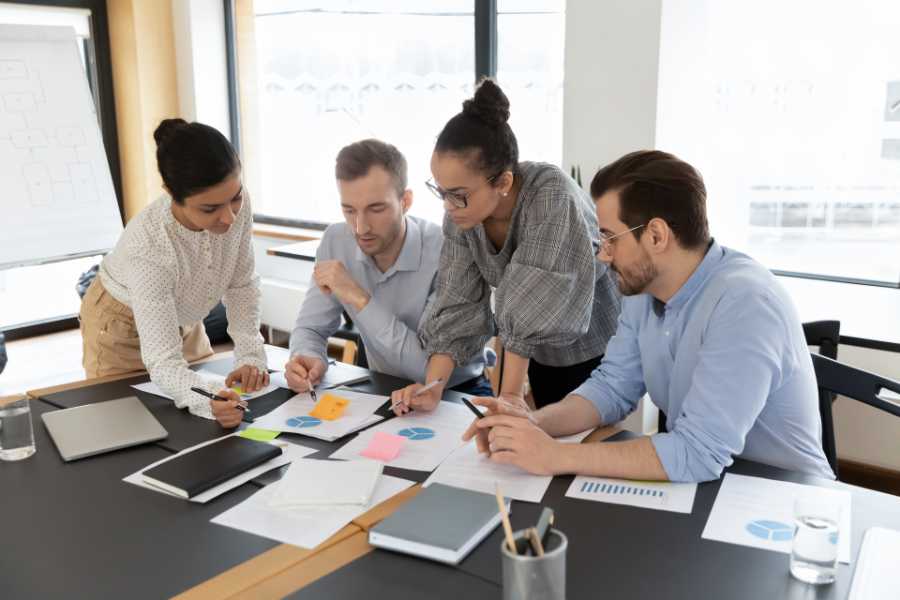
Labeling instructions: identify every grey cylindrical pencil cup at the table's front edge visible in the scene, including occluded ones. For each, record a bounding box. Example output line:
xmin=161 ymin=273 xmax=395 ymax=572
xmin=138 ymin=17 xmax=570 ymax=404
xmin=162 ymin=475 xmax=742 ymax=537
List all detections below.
xmin=500 ymin=529 xmax=569 ymax=600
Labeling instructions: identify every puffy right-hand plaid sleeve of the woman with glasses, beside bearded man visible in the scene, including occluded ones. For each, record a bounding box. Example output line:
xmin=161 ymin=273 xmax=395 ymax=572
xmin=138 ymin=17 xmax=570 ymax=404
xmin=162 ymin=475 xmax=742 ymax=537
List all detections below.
xmin=496 ymin=186 xmax=596 ymax=358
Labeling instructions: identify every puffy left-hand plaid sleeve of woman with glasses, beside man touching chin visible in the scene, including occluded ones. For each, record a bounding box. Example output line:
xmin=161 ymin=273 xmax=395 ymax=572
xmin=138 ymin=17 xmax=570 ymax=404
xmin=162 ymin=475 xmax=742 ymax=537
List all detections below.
xmin=419 ymin=217 xmax=494 ymax=365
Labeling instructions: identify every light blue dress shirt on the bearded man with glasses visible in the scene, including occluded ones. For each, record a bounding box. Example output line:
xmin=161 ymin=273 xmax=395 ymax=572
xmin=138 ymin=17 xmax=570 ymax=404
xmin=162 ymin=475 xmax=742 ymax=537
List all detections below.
xmin=573 ymin=242 xmax=834 ymax=481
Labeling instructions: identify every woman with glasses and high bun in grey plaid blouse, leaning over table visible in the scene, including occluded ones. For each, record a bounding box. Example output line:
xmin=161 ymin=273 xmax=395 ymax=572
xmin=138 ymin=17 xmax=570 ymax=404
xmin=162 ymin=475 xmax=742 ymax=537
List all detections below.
xmin=393 ymin=79 xmax=619 ymax=414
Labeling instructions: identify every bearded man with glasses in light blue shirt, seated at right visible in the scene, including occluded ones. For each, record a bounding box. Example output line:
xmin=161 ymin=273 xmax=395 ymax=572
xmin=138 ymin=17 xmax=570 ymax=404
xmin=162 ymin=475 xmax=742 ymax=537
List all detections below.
xmin=466 ymin=151 xmax=834 ymax=481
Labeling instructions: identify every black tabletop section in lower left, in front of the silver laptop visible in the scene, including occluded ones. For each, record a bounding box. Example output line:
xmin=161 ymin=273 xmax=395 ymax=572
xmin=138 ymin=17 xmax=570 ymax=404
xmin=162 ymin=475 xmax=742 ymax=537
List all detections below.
xmin=0 ymin=400 xmax=277 ymax=598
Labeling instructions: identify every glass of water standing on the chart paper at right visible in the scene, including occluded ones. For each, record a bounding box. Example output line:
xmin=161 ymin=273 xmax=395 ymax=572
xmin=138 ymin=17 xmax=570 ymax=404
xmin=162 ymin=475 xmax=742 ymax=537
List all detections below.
xmin=791 ymin=498 xmax=841 ymax=584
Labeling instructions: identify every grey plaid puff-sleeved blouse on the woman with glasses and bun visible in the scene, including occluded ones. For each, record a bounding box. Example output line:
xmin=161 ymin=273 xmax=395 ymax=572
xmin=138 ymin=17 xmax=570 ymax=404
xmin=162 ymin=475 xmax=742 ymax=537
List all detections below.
xmin=420 ymin=162 xmax=620 ymax=366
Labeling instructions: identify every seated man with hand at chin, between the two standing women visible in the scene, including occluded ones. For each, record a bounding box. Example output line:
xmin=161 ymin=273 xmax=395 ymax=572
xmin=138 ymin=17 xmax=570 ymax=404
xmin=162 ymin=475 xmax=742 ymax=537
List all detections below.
xmin=285 ymin=139 xmax=492 ymax=396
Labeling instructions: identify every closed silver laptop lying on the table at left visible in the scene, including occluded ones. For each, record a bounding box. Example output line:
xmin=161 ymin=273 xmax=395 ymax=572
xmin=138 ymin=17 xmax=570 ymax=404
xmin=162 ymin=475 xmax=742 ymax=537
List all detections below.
xmin=41 ymin=396 xmax=169 ymax=462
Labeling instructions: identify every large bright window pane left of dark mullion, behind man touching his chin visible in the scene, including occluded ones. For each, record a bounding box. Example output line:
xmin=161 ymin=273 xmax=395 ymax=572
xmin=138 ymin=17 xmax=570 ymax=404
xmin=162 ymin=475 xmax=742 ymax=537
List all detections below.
xmin=254 ymin=0 xmax=475 ymax=223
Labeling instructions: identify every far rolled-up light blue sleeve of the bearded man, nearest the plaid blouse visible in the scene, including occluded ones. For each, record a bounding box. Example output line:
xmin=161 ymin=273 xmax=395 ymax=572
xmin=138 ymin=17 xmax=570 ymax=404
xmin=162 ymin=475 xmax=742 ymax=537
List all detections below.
xmin=572 ymin=300 xmax=647 ymax=425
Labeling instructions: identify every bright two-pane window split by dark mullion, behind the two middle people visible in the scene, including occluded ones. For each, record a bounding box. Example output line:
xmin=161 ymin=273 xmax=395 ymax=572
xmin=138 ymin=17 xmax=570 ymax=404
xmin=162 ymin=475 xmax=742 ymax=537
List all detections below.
xmin=239 ymin=0 xmax=565 ymax=223
